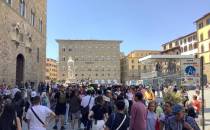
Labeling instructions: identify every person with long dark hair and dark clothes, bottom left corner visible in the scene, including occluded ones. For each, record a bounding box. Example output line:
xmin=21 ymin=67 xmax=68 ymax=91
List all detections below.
xmin=0 ymin=99 xmax=22 ymax=130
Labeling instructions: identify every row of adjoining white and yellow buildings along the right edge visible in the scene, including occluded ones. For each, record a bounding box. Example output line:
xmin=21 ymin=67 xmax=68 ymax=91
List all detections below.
xmin=159 ymin=13 xmax=210 ymax=83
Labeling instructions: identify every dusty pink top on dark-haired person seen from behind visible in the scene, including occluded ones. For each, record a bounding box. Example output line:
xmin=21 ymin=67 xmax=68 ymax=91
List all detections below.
xmin=130 ymin=101 xmax=147 ymax=130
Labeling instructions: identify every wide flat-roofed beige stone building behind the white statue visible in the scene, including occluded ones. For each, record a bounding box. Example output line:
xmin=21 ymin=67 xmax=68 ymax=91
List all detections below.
xmin=57 ymin=40 xmax=121 ymax=83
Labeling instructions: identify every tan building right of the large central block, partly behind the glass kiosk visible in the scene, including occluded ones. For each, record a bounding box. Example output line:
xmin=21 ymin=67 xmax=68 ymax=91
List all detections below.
xmin=120 ymin=50 xmax=160 ymax=85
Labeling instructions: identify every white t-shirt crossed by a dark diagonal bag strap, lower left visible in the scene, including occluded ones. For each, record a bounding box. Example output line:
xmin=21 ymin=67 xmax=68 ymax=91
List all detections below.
xmin=26 ymin=105 xmax=52 ymax=130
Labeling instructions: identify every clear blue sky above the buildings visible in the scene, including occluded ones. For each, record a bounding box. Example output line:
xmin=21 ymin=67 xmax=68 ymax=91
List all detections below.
xmin=47 ymin=0 xmax=210 ymax=59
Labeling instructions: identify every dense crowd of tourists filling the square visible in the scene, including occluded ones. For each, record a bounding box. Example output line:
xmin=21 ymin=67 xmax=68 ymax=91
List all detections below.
xmin=0 ymin=83 xmax=202 ymax=130
